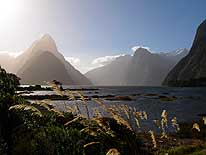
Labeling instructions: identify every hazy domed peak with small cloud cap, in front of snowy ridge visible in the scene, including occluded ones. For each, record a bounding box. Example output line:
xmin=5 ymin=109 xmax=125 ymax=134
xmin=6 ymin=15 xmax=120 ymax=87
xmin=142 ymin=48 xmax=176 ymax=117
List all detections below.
xmin=127 ymin=48 xmax=173 ymax=86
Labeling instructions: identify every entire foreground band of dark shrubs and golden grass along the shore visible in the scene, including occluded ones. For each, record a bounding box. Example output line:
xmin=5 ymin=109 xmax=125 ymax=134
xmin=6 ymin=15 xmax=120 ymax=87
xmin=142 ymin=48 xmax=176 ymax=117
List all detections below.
xmin=0 ymin=68 xmax=206 ymax=155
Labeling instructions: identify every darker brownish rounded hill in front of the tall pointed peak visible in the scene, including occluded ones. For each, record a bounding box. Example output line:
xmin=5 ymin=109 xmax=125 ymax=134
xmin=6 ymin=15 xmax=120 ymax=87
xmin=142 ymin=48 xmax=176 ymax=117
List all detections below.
xmin=20 ymin=52 xmax=74 ymax=84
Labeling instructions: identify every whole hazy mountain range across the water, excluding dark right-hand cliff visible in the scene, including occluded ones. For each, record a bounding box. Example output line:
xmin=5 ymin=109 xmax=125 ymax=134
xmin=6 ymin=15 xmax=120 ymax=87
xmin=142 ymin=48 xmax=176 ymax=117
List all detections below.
xmin=0 ymin=34 xmax=191 ymax=86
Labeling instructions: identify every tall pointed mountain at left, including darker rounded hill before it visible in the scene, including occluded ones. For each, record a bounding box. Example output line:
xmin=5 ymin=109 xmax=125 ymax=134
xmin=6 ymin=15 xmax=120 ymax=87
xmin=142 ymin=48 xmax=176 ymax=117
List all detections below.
xmin=0 ymin=34 xmax=91 ymax=85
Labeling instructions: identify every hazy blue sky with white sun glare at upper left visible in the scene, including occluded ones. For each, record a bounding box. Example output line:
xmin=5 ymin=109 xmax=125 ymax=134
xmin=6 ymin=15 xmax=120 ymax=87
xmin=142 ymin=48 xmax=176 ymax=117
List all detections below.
xmin=0 ymin=0 xmax=206 ymax=72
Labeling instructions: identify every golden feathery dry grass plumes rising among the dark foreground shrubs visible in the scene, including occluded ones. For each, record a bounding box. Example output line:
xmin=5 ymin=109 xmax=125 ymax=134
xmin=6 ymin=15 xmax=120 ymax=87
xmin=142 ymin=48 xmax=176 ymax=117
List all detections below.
xmin=45 ymin=83 xmax=206 ymax=151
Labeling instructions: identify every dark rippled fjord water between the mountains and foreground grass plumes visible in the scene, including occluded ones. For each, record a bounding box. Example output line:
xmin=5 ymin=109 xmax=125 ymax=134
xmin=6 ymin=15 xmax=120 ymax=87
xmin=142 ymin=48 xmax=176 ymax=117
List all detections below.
xmin=27 ymin=86 xmax=206 ymax=131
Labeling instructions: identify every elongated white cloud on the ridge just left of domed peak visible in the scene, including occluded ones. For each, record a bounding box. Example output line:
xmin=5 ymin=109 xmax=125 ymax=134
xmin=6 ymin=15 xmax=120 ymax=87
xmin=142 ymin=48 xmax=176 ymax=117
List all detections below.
xmin=92 ymin=54 xmax=125 ymax=68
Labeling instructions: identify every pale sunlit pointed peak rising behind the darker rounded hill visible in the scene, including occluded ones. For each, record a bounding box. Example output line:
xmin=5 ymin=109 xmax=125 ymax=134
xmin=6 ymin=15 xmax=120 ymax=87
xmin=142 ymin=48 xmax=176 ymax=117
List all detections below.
xmin=15 ymin=34 xmax=91 ymax=85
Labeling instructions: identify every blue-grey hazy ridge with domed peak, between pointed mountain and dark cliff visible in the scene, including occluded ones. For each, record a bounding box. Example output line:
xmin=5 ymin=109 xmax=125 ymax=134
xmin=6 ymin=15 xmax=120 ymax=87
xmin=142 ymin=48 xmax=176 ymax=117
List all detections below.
xmin=85 ymin=47 xmax=188 ymax=86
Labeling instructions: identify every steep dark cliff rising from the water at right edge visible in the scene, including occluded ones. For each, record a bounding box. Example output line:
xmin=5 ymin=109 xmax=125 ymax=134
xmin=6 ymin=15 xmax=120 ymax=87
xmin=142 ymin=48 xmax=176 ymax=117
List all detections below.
xmin=163 ymin=20 xmax=206 ymax=86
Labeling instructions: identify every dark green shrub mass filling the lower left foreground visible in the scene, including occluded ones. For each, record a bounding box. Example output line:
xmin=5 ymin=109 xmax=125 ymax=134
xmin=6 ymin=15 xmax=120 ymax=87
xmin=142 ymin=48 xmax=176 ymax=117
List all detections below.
xmin=0 ymin=68 xmax=148 ymax=155
